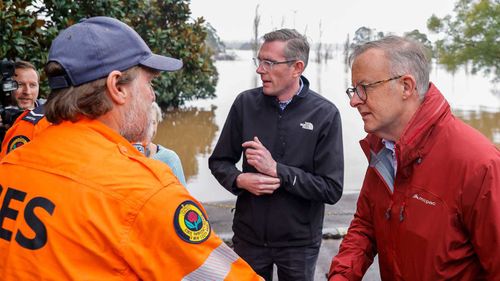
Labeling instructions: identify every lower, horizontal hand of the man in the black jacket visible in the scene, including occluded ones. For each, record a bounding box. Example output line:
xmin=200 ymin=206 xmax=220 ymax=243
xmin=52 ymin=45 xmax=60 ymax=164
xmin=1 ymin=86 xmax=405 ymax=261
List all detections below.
xmin=236 ymin=173 xmax=280 ymax=196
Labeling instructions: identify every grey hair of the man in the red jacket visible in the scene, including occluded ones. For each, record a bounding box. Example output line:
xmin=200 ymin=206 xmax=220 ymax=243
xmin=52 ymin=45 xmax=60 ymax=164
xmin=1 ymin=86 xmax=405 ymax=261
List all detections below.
xmin=349 ymin=35 xmax=430 ymax=99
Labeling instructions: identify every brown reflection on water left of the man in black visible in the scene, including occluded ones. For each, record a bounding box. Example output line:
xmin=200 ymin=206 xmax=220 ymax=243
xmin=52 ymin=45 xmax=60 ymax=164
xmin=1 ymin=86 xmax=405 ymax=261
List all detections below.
xmin=154 ymin=106 xmax=219 ymax=181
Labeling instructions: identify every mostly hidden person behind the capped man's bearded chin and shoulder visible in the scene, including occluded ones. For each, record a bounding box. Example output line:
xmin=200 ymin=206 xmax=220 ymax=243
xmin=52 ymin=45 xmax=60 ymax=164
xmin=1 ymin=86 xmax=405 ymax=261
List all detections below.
xmin=133 ymin=102 xmax=187 ymax=186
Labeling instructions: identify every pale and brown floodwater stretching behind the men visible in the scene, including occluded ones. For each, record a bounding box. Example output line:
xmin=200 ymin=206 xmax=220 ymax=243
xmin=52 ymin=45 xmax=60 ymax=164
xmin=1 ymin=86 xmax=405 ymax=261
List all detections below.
xmin=155 ymin=51 xmax=500 ymax=202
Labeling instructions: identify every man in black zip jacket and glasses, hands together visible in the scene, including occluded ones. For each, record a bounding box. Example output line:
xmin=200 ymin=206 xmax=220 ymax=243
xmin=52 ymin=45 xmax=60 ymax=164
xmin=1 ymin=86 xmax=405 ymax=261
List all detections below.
xmin=209 ymin=29 xmax=344 ymax=281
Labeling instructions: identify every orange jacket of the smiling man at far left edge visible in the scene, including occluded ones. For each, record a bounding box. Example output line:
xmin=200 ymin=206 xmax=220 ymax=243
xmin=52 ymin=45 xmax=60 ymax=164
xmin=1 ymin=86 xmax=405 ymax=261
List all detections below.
xmin=0 ymin=105 xmax=50 ymax=160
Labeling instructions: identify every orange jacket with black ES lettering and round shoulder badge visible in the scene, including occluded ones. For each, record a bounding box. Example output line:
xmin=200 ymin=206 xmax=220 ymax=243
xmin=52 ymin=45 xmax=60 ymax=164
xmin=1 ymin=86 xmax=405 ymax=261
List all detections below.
xmin=0 ymin=119 xmax=262 ymax=281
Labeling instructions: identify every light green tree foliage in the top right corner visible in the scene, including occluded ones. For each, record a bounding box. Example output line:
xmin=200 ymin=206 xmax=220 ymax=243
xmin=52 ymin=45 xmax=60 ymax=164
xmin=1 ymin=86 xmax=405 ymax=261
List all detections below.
xmin=427 ymin=0 xmax=500 ymax=81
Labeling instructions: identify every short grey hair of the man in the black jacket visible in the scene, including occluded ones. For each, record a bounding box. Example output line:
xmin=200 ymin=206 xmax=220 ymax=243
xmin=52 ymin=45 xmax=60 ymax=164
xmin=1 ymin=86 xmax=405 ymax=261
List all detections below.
xmin=263 ymin=28 xmax=309 ymax=67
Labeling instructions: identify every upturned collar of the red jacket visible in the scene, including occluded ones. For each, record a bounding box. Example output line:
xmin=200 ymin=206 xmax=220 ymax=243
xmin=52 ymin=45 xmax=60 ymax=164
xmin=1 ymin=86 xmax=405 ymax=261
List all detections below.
xmin=360 ymin=83 xmax=451 ymax=172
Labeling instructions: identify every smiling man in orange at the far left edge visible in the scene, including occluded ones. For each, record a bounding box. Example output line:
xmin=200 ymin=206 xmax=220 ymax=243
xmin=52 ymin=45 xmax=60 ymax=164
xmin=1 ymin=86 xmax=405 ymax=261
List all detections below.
xmin=0 ymin=61 xmax=50 ymax=156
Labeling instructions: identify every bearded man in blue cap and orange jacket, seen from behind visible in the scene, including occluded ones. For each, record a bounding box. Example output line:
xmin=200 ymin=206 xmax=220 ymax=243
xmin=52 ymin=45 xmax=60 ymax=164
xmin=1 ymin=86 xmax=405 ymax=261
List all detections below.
xmin=0 ymin=17 xmax=262 ymax=280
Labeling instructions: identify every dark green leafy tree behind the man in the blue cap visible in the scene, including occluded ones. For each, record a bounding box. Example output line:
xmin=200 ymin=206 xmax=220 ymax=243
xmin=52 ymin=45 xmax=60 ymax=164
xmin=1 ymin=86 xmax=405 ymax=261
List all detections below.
xmin=0 ymin=0 xmax=218 ymax=108
